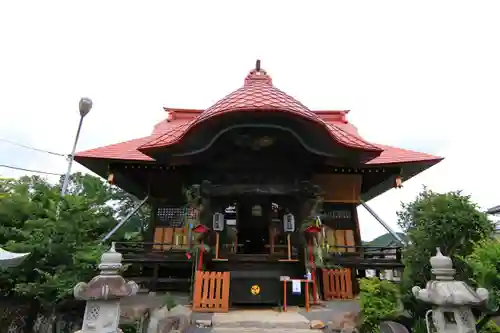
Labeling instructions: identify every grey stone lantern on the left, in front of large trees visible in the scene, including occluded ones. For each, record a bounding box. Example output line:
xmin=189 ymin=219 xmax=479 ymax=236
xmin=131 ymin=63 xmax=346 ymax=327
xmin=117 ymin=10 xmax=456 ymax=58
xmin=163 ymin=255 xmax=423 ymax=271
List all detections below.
xmin=73 ymin=243 xmax=139 ymax=333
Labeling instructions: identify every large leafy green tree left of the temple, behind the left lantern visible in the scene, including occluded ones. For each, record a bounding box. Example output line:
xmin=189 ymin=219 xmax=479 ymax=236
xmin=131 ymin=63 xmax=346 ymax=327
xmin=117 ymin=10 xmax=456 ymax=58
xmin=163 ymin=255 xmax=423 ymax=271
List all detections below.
xmin=0 ymin=173 xmax=148 ymax=322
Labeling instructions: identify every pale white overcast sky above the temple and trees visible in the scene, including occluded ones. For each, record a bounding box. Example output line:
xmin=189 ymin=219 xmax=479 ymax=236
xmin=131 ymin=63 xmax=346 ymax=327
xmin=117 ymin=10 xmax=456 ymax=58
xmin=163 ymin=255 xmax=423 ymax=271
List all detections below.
xmin=0 ymin=0 xmax=500 ymax=239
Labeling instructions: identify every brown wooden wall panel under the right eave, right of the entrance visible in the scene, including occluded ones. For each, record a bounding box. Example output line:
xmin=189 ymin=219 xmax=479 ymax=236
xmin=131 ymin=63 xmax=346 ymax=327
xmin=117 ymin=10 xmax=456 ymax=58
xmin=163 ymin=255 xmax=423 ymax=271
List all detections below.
xmin=312 ymin=174 xmax=362 ymax=203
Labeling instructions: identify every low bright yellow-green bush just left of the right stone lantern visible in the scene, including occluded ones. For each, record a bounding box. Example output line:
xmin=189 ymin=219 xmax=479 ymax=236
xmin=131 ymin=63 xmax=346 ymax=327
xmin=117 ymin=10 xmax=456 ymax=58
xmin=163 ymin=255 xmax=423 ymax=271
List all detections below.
xmin=360 ymin=278 xmax=400 ymax=333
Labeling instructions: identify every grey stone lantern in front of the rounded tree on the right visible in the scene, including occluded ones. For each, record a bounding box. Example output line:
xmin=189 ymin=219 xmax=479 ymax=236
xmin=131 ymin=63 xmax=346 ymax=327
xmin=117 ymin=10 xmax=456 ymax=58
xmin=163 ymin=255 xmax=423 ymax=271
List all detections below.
xmin=412 ymin=248 xmax=488 ymax=333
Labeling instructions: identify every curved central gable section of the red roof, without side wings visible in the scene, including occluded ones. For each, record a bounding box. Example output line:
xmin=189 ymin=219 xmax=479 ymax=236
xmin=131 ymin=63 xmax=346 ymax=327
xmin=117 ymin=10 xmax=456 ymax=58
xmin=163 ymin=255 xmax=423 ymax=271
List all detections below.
xmin=139 ymin=70 xmax=380 ymax=151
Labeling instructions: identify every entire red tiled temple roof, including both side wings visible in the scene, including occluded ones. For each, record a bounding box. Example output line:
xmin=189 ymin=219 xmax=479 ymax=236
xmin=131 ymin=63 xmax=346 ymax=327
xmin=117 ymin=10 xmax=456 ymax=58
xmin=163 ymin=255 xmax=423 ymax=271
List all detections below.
xmin=75 ymin=61 xmax=441 ymax=166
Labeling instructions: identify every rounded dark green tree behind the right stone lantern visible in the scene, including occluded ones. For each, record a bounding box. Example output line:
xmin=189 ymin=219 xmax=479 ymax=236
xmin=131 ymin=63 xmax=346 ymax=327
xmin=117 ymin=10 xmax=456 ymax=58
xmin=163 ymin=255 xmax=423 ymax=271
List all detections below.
xmin=398 ymin=188 xmax=493 ymax=317
